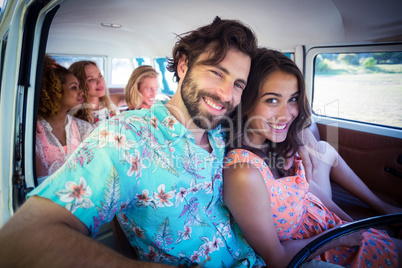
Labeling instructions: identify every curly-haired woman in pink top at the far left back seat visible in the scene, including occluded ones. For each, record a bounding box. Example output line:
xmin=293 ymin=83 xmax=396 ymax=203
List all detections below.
xmin=35 ymin=55 xmax=93 ymax=182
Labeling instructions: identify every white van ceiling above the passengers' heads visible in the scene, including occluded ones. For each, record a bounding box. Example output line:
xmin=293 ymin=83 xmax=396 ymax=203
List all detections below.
xmin=47 ymin=0 xmax=402 ymax=57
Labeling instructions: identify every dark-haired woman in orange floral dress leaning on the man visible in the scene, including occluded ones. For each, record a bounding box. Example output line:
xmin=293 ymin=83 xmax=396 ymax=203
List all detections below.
xmin=223 ymin=48 xmax=402 ymax=267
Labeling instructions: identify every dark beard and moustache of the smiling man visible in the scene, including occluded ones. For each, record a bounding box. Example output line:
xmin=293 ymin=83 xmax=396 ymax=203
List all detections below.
xmin=181 ymin=70 xmax=234 ymax=130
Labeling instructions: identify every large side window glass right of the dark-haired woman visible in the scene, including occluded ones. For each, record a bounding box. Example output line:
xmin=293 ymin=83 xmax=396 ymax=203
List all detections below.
xmin=313 ymin=52 xmax=402 ymax=128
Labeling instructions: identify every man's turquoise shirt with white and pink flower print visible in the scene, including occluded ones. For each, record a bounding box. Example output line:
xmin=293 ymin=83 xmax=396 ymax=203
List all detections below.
xmin=30 ymin=103 xmax=263 ymax=267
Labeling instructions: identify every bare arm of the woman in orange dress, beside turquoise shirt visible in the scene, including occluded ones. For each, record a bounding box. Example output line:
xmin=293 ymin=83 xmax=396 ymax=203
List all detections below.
xmin=223 ymin=163 xmax=362 ymax=267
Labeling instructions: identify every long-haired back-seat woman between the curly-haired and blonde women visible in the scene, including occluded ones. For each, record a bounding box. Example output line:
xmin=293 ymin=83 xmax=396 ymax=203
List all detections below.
xmin=68 ymin=61 xmax=119 ymax=127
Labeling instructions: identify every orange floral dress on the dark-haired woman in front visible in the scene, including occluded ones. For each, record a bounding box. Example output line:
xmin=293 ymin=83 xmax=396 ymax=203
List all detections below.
xmin=225 ymin=149 xmax=398 ymax=267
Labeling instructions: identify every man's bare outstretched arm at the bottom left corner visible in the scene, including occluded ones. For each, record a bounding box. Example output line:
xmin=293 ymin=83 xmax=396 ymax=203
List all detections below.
xmin=0 ymin=196 xmax=168 ymax=267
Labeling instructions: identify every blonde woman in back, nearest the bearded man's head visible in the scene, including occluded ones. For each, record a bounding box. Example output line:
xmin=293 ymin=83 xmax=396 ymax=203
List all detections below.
xmin=124 ymin=65 xmax=159 ymax=110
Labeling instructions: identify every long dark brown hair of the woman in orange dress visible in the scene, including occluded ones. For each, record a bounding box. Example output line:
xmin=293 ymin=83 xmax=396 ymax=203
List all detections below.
xmin=224 ymin=48 xmax=311 ymax=175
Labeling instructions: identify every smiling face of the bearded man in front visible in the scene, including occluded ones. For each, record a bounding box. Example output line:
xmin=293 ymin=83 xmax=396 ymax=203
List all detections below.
xmin=181 ymin=49 xmax=251 ymax=129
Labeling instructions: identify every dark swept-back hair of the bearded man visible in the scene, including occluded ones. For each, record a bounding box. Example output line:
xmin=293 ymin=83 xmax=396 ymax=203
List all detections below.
xmin=167 ymin=16 xmax=257 ymax=82
